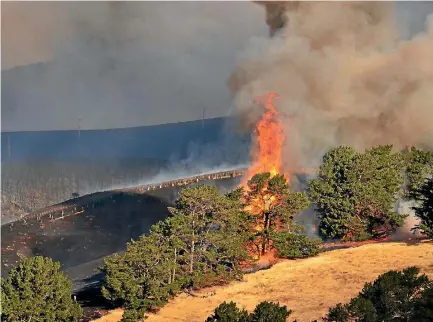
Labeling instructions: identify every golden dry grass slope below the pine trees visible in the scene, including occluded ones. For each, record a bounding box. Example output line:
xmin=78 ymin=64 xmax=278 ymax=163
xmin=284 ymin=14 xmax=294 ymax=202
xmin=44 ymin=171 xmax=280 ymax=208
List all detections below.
xmin=95 ymin=243 xmax=433 ymax=322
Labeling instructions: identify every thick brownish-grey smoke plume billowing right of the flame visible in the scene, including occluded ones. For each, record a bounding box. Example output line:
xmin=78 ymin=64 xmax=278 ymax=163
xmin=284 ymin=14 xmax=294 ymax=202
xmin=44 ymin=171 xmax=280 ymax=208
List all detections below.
xmin=230 ymin=1 xmax=433 ymax=169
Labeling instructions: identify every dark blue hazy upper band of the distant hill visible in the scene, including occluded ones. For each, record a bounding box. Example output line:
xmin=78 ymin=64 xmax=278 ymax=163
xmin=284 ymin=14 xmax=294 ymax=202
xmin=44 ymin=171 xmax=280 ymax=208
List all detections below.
xmin=1 ymin=117 xmax=249 ymax=163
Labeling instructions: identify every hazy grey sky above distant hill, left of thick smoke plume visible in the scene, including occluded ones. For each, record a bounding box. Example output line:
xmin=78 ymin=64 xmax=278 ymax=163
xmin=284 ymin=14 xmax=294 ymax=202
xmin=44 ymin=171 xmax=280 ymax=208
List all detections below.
xmin=1 ymin=2 xmax=433 ymax=131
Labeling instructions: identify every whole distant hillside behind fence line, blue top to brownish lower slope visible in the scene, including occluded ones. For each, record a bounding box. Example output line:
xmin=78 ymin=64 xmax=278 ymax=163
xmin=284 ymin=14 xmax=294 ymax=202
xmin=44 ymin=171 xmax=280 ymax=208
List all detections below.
xmin=1 ymin=118 xmax=250 ymax=218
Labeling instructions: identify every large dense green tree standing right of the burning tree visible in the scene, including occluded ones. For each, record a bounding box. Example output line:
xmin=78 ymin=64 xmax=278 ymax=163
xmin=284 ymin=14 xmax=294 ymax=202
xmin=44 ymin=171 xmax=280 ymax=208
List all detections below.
xmin=309 ymin=145 xmax=406 ymax=239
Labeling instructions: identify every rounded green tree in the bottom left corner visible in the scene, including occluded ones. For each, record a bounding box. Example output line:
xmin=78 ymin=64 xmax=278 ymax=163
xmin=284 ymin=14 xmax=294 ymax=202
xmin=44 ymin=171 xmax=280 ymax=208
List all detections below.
xmin=1 ymin=256 xmax=82 ymax=322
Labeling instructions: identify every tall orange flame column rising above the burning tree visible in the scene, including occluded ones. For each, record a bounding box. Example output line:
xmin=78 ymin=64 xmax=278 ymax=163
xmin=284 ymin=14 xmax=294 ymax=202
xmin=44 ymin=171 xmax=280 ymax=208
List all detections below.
xmin=242 ymin=93 xmax=285 ymax=187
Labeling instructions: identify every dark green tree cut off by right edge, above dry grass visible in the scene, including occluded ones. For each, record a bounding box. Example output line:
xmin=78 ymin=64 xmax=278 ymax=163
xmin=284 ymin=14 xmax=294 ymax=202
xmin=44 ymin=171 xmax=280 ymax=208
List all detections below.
xmin=414 ymin=178 xmax=433 ymax=238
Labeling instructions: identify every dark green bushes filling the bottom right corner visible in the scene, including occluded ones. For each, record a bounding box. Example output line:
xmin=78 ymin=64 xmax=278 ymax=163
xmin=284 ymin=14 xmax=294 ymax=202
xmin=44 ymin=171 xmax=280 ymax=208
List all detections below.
xmin=324 ymin=267 xmax=433 ymax=322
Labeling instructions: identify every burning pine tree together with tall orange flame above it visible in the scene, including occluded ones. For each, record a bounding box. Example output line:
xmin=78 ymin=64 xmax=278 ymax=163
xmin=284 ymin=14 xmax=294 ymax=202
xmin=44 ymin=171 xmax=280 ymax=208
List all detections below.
xmin=236 ymin=93 xmax=309 ymax=258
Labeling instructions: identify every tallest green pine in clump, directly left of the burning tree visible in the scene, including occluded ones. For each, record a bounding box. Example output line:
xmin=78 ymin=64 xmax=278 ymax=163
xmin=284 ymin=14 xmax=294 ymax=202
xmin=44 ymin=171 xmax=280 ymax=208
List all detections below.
xmin=169 ymin=185 xmax=248 ymax=287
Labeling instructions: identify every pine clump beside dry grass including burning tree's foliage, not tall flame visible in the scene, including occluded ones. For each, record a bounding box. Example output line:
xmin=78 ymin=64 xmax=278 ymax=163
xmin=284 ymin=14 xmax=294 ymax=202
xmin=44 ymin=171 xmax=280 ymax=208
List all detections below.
xmin=101 ymin=180 xmax=317 ymax=321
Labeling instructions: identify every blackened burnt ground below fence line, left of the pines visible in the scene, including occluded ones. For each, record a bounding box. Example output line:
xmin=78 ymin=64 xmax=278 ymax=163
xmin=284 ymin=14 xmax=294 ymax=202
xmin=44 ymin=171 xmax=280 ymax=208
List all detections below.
xmin=1 ymin=178 xmax=239 ymax=284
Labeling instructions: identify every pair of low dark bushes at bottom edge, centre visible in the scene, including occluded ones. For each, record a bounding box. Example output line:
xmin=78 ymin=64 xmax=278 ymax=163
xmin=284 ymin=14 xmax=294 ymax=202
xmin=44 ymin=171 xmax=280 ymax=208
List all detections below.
xmin=205 ymin=301 xmax=292 ymax=322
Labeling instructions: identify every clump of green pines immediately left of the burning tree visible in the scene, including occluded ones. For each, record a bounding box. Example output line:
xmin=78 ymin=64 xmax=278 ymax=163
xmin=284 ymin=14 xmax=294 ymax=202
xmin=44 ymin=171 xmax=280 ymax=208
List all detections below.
xmin=101 ymin=185 xmax=249 ymax=318
